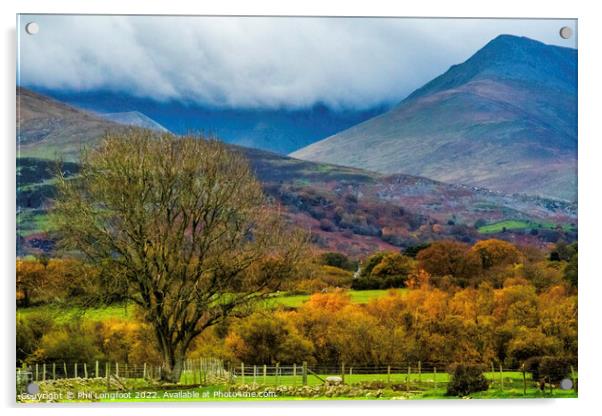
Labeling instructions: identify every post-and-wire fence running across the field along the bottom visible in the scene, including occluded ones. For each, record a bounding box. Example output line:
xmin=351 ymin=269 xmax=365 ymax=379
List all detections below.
xmin=17 ymin=358 xmax=577 ymax=393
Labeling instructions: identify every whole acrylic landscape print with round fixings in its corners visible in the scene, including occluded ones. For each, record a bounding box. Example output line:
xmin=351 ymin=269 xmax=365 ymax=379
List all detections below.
xmin=15 ymin=14 xmax=578 ymax=403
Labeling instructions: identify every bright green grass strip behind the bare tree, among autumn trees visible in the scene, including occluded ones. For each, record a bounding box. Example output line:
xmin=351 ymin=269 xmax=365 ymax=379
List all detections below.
xmin=17 ymin=289 xmax=398 ymax=323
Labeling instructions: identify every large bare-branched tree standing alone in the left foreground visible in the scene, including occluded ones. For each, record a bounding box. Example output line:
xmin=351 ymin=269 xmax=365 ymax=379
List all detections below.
xmin=54 ymin=129 xmax=305 ymax=382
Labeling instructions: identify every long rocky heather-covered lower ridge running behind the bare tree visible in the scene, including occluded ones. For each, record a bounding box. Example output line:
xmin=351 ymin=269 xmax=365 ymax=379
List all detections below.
xmin=17 ymin=89 xmax=577 ymax=257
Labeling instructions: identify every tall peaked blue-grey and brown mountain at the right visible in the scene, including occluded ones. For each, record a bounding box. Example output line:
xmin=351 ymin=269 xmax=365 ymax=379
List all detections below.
xmin=291 ymin=35 xmax=577 ymax=201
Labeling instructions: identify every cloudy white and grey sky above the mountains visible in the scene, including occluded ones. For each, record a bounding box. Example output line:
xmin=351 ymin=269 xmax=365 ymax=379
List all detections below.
xmin=17 ymin=15 xmax=577 ymax=110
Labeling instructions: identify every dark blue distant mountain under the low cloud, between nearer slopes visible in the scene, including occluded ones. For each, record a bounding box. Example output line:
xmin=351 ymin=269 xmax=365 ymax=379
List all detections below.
xmin=27 ymin=89 xmax=388 ymax=154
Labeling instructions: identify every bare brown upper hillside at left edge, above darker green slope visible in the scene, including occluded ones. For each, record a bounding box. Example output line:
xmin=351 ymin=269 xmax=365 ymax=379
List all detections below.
xmin=17 ymin=88 xmax=122 ymax=160
